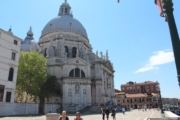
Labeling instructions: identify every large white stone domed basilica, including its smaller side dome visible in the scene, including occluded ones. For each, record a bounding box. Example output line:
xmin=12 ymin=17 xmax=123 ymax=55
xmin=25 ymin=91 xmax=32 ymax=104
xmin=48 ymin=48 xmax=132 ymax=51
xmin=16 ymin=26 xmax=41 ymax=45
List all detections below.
xmin=21 ymin=1 xmax=115 ymax=111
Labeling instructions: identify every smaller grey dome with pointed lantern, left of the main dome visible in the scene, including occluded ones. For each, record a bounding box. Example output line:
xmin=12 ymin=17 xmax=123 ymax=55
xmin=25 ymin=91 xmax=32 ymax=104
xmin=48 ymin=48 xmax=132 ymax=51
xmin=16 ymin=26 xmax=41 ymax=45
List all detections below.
xmin=21 ymin=27 xmax=37 ymax=52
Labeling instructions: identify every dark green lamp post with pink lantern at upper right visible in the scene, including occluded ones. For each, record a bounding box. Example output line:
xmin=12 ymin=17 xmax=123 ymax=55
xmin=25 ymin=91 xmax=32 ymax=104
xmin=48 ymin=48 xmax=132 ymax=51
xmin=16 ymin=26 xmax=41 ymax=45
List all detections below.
xmin=155 ymin=0 xmax=180 ymax=86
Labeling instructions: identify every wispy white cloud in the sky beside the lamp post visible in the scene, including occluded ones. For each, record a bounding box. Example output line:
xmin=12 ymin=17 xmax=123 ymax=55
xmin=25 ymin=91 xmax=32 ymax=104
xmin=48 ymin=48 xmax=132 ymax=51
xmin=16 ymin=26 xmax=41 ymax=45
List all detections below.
xmin=135 ymin=50 xmax=174 ymax=73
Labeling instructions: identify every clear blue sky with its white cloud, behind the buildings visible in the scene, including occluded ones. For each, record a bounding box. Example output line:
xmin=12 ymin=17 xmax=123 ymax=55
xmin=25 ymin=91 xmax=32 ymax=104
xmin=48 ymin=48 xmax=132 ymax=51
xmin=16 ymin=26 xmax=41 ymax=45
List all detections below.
xmin=0 ymin=0 xmax=180 ymax=98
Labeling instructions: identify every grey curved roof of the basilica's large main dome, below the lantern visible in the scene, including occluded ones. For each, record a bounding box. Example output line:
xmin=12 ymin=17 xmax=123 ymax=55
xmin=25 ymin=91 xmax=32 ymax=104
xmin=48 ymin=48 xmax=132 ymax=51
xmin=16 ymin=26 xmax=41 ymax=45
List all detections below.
xmin=41 ymin=15 xmax=87 ymax=37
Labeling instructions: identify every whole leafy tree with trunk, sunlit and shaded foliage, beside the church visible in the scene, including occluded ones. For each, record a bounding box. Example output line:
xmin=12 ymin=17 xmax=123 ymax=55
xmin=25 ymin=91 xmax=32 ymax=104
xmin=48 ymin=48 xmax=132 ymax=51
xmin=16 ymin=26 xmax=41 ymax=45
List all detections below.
xmin=16 ymin=52 xmax=60 ymax=114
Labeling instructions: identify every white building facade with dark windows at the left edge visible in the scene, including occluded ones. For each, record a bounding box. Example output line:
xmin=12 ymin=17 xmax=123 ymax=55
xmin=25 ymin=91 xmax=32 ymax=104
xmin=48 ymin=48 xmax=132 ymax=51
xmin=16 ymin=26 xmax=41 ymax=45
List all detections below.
xmin=0 ymin=29 xmax=22 ymax=103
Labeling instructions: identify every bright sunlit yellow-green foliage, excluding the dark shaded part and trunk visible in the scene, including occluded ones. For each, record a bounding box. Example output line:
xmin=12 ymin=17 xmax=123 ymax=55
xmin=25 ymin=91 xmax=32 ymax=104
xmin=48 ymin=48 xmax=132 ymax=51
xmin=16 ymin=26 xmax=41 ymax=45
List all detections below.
xmin=17 ymin=52 xmax=47 ymax=96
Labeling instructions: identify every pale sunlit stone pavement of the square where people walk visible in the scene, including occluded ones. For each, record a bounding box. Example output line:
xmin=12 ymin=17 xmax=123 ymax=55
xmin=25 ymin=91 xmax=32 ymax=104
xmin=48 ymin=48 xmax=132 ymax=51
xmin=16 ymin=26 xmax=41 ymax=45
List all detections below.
xmin=0 ymin=110 xmax=161 ymax=120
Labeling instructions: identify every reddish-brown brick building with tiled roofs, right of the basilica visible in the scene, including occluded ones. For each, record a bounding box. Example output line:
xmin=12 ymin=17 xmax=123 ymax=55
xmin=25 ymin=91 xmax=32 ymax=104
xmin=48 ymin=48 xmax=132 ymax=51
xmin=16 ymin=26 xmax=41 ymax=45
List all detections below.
xmin=115 ymin=81 xmax=159 ymax=108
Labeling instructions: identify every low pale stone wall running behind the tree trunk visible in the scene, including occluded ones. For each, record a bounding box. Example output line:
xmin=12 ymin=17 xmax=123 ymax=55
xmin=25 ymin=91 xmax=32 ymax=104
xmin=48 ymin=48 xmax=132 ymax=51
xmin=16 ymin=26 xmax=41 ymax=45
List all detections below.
xmin=0 ymin=102 xmax=60 ymax=116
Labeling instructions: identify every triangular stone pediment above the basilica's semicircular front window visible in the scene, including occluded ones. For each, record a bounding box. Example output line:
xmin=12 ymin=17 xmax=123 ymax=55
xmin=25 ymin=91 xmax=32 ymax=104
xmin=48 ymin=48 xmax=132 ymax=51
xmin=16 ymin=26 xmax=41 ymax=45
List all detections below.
xmin=64 ymin=57 xmax=90 ymax=65
